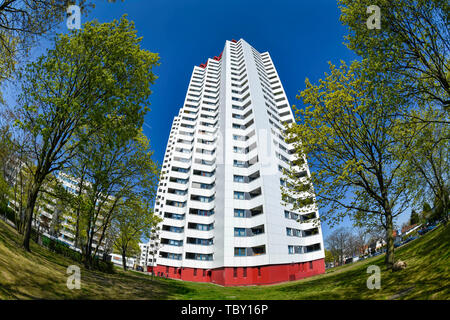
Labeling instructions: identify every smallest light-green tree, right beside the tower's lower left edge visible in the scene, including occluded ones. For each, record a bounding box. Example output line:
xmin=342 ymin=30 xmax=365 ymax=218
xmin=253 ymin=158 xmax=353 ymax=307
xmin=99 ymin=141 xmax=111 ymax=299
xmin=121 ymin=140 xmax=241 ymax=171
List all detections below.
xmin=113 ymin=198 xmax=160 ymax=271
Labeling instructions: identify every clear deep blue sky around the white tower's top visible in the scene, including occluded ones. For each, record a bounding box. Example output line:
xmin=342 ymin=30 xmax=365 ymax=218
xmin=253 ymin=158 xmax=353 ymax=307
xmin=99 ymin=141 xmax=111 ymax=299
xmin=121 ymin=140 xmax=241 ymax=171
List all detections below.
xmin=4 ymin=0 xmax=409 ymax=238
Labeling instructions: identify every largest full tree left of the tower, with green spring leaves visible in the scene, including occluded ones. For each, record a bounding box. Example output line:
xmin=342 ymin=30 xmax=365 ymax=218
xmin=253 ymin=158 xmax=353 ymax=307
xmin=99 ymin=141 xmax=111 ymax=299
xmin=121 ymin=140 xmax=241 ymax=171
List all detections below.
xmin=13 ymin=17 xmax=159 ymax=250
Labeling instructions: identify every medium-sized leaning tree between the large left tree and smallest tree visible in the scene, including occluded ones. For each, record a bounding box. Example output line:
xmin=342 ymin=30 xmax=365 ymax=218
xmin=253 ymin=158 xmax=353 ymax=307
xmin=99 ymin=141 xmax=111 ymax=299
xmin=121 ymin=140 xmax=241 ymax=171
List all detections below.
xmin=76 ymin=129 xmax=158 ymax=268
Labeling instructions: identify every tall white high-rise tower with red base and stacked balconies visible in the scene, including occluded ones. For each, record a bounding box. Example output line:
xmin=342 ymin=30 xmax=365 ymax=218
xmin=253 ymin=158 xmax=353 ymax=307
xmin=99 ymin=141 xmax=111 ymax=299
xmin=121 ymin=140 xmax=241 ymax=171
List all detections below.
xmin=154 ymin=39 xmax=325 ymax=286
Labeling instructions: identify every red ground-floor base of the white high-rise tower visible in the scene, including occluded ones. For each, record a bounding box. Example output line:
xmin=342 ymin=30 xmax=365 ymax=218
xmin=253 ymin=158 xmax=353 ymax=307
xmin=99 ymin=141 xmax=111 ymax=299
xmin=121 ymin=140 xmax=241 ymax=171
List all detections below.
xmin=147 ymin=259 xmax=325 ymax=286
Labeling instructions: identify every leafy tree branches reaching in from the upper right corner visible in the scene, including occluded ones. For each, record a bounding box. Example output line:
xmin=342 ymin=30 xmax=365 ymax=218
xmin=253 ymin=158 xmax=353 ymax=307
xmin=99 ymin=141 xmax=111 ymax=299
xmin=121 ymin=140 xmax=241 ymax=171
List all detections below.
xmin=339 ymin=0 xmax=450 ymax=109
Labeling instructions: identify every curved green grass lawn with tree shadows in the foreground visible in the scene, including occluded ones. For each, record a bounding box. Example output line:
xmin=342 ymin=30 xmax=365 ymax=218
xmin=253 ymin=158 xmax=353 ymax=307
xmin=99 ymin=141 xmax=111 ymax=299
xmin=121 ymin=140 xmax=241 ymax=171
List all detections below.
xmin=0 ymin=221 xmax=450 ymax=300
